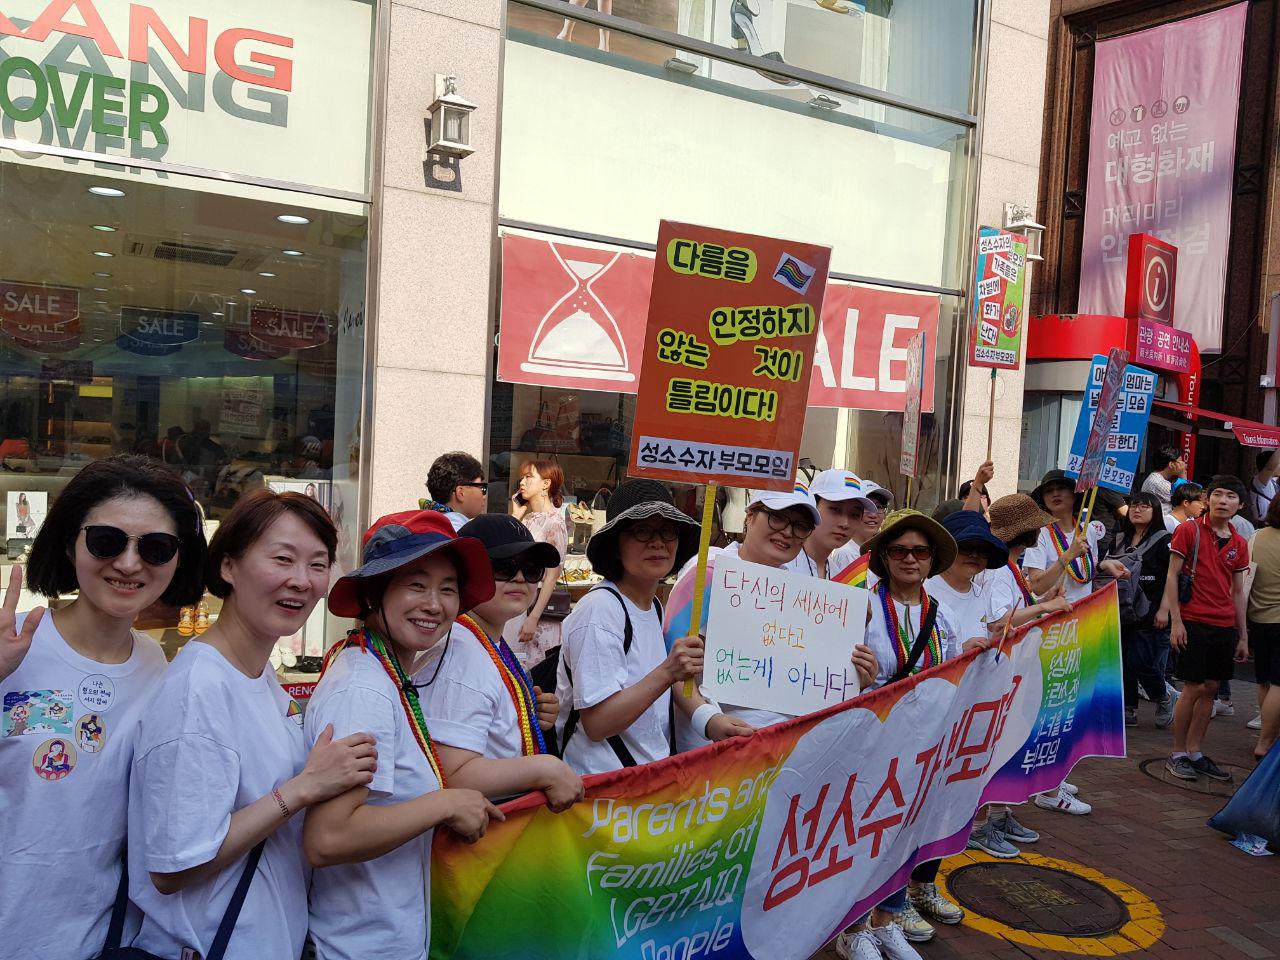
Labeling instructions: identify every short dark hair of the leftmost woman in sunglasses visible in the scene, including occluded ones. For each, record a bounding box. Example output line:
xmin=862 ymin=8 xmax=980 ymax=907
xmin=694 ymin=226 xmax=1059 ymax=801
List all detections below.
xmin=27 ymin=454 xmax=207 ymax=607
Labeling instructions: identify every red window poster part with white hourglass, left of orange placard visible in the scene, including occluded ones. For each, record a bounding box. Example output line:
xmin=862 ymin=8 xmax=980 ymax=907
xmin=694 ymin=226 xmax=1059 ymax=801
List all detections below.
xmin=488 ymin=234 xmax=653 ymax=393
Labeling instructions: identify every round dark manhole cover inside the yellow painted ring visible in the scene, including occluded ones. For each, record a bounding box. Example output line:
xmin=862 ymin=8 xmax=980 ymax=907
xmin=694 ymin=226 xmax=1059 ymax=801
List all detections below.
xmin=947 ymin=863 xmax=1129 ymax=937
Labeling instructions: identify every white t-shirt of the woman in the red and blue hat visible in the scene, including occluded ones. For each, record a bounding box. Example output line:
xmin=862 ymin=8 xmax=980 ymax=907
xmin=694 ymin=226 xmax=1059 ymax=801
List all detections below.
xmin=305 ymin=644 xmax=442 ymax=960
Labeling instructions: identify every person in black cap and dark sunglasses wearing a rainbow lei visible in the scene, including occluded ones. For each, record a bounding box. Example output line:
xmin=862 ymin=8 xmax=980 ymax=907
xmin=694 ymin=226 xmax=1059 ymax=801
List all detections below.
xmin=415 ymin=513 xmax=582 ymax=813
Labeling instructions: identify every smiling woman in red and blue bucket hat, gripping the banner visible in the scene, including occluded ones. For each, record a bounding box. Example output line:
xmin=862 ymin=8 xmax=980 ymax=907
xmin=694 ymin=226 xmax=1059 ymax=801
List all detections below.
xmin=304 ymin=511 xmax=504 ymax=960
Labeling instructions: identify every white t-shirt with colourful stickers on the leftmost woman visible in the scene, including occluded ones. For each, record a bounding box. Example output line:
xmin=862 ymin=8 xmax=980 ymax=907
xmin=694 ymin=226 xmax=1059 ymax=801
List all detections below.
xmin=0 ymin=611 xmax=165 ymax=960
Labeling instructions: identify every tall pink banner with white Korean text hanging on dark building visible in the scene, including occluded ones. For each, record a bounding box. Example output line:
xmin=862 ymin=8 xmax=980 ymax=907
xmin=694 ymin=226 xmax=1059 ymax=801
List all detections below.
xmin=1079 ymin=3 xmax=1248 ymax=352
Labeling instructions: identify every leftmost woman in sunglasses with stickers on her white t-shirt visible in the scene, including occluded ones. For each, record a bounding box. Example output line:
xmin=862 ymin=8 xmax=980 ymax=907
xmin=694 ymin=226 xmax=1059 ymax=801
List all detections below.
xmin=0 ymin=456 xmax=205 ymax=957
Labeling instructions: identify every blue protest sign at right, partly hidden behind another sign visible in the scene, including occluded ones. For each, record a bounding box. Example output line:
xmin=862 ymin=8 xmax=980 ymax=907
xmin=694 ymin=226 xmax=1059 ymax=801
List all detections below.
xmin=1066 ymin=351 xmax=1156 ymax=494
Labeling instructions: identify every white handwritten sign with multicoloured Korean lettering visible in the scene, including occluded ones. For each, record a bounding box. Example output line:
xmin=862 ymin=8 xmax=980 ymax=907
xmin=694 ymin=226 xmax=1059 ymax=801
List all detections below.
xmin=703 ymin=553 xmax=867 ymax=717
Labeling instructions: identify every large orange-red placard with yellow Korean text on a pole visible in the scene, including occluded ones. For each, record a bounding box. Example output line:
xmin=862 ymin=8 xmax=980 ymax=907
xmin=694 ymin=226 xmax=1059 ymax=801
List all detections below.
xmin=628 ymin=220 xmax=831 ymax=490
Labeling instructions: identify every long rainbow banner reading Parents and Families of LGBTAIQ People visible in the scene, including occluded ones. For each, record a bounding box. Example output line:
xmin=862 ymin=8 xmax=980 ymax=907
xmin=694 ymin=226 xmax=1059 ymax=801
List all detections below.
xmin=430 ymin=585 xmax=1125 ymax=960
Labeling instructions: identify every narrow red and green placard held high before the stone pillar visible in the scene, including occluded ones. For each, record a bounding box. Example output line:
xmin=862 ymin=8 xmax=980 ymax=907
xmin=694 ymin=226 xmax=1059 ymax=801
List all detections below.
xmin=969 ymin=227 xmax=1027 ymax=370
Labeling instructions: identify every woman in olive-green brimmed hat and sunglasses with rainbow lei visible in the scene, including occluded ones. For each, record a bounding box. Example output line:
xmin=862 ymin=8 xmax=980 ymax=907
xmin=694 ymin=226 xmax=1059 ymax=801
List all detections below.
xmin=836 ymin=508 xmax=977 ymax=960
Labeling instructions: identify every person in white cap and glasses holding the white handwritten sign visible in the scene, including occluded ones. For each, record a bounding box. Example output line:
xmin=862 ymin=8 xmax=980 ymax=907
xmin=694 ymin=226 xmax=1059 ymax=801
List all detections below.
xmin=664 ymin=484 xmax=879 ymax=751
